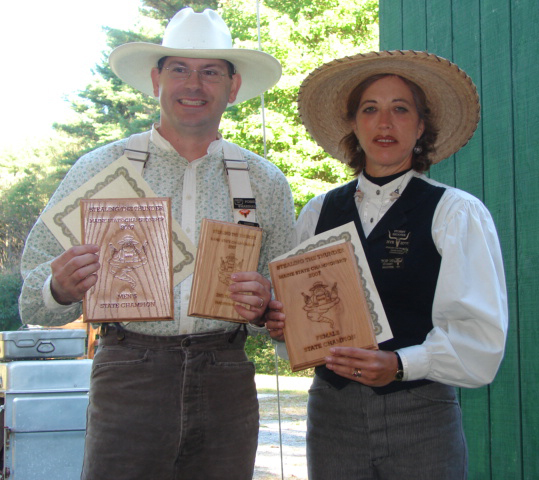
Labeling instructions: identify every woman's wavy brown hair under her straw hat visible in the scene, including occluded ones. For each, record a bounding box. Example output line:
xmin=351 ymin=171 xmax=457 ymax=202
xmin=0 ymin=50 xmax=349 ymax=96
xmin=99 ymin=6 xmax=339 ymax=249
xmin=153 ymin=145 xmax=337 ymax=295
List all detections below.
xmin=341 ymin=73 xmax=438 ymax=175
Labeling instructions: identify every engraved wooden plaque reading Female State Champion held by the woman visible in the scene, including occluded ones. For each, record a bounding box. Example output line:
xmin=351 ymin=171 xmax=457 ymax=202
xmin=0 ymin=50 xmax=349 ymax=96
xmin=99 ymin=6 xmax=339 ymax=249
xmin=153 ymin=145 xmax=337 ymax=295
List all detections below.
xmin=269 ymin=242 xmax=378 ymax=372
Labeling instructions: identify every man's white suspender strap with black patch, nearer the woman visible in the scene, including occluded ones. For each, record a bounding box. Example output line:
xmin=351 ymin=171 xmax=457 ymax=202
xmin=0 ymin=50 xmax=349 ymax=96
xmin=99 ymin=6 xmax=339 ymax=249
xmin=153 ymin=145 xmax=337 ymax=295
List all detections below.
xmin=223 ymin=140 xmax=259 ymax=227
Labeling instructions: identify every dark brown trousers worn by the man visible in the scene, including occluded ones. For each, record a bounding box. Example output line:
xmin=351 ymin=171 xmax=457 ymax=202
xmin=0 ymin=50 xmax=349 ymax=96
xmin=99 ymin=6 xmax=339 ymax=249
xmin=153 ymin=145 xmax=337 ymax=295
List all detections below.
xmin=81 ymin=328 xmax=259 ymax=480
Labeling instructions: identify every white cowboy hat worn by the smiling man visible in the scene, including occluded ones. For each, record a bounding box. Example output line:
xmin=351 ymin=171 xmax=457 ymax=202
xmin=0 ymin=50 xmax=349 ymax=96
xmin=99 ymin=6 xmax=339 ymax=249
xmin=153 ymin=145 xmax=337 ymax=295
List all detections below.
xmin=109 ymin=8 xmax=282 ymax=105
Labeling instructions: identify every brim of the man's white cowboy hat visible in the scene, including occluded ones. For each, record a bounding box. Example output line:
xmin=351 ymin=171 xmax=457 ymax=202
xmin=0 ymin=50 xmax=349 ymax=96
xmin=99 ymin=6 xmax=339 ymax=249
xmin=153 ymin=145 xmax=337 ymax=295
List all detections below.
xmin=109 ymin=42 xmax=282 ymax=105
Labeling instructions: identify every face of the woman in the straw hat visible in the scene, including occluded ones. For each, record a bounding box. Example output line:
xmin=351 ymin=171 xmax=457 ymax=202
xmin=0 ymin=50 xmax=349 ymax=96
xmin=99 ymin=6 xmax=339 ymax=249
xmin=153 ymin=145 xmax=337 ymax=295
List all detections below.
xmin=352 ymin=76 xmax=424 ymax=177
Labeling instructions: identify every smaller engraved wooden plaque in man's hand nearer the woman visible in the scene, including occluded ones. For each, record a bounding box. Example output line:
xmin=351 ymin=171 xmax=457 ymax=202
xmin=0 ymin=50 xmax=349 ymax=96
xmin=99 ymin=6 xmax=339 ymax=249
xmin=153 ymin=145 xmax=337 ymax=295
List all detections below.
xmin=188 ymin=218 xmax=262 ymax=323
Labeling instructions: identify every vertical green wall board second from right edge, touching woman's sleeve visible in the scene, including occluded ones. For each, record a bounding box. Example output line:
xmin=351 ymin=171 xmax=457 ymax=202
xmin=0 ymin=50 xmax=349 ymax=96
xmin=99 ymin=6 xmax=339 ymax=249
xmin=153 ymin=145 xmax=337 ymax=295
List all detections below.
xmin=479 ymin=0 xmax=522 ymax=480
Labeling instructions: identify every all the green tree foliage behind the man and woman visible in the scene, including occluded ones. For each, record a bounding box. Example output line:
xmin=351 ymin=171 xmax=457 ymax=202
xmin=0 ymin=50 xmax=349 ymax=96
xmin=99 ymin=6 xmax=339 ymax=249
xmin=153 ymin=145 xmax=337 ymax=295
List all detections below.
xmin=0 ymin=0 xmax=378 ymax=334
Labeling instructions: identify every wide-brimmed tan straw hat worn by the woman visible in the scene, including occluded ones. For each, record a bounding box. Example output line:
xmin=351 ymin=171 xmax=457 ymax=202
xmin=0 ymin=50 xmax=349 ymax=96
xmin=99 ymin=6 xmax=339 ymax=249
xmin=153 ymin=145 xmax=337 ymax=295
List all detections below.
xmin=298 ymin=50 xmax=480 ymax=163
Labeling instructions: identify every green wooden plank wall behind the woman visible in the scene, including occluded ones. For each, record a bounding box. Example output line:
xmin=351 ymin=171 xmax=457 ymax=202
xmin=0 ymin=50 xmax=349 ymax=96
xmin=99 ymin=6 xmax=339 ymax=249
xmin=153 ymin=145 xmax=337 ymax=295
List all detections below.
xmin=380 ymin=0 xmax=539 ymax=480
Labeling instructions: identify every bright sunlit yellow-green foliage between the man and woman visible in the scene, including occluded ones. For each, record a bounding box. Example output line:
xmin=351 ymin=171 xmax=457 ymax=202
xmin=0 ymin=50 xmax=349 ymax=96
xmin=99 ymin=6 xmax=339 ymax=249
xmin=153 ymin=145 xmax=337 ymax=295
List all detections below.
xmin=220 ymin=0 xmax=378 ymax=213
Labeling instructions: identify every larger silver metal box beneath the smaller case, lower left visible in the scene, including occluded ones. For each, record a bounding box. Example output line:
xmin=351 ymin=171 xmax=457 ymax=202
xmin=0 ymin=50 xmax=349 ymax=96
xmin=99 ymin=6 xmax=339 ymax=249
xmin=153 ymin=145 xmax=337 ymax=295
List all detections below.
xmin=0 ymin=359 xmax=92 ymax=480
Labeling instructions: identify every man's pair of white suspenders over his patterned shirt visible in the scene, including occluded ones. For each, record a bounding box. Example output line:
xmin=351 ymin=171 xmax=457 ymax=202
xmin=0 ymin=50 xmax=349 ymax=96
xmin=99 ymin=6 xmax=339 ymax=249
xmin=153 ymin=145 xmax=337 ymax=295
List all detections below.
xmin=124 ymin=131 xmax=259 ymax=227
